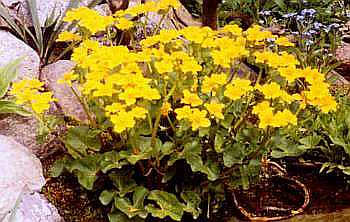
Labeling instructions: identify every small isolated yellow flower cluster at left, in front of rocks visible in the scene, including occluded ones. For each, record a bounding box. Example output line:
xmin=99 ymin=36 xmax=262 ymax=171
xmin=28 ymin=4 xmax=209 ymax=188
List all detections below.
xmin=11 ymin=79 xmax=54 ymax=114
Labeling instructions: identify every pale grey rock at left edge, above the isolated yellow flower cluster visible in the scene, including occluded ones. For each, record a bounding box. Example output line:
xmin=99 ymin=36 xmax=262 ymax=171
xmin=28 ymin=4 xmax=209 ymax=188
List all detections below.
xmin=0 ymin=30 xmax=40 ymax=79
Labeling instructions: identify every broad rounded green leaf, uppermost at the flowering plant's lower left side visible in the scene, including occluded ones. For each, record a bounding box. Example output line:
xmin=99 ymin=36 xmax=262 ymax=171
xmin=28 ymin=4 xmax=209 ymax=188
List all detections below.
xmin=64 ymin=126 xmax=101 ymax=158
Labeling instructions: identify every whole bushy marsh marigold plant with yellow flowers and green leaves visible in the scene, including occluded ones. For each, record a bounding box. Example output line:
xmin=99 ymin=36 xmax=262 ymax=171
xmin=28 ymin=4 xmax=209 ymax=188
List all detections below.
xmin=12 ymin=0 xmax=337 ymax=221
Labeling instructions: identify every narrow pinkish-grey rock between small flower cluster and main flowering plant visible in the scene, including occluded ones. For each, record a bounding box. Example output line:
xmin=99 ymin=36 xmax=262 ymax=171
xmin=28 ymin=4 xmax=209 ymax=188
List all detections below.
xmin=41 ymin=60 xmax=87 ymax=122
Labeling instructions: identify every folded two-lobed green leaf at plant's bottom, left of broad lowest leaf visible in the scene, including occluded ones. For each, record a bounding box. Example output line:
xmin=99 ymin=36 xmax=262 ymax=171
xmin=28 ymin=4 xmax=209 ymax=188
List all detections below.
xmin=114 ymin=186 xmax=149 ymax=219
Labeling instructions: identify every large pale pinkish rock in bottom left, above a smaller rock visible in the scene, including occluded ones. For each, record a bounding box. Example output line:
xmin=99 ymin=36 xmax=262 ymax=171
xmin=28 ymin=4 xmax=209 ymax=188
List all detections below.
xmin=0 ymin=135 xmax=45 ymax=221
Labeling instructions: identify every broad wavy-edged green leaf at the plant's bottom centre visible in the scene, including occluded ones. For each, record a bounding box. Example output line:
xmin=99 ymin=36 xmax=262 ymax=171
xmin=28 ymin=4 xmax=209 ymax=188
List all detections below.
xmin=146 ymin=190 xmax=186 ymax=221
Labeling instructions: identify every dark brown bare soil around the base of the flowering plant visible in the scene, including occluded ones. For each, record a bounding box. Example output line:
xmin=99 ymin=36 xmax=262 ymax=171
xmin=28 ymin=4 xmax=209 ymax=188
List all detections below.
xmin=42 ymin=154 xmax=350 ymax=222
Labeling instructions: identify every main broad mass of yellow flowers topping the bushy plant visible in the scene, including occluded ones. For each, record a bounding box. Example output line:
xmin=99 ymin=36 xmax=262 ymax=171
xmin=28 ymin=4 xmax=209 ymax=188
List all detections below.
xmin=47 ymin=0 xmax=337 ymax=133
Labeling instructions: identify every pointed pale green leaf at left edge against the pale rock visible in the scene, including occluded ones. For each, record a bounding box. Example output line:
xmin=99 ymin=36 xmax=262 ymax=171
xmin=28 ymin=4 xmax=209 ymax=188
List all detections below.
xmin=0 ymin=58 xmax=23 ymax=99
